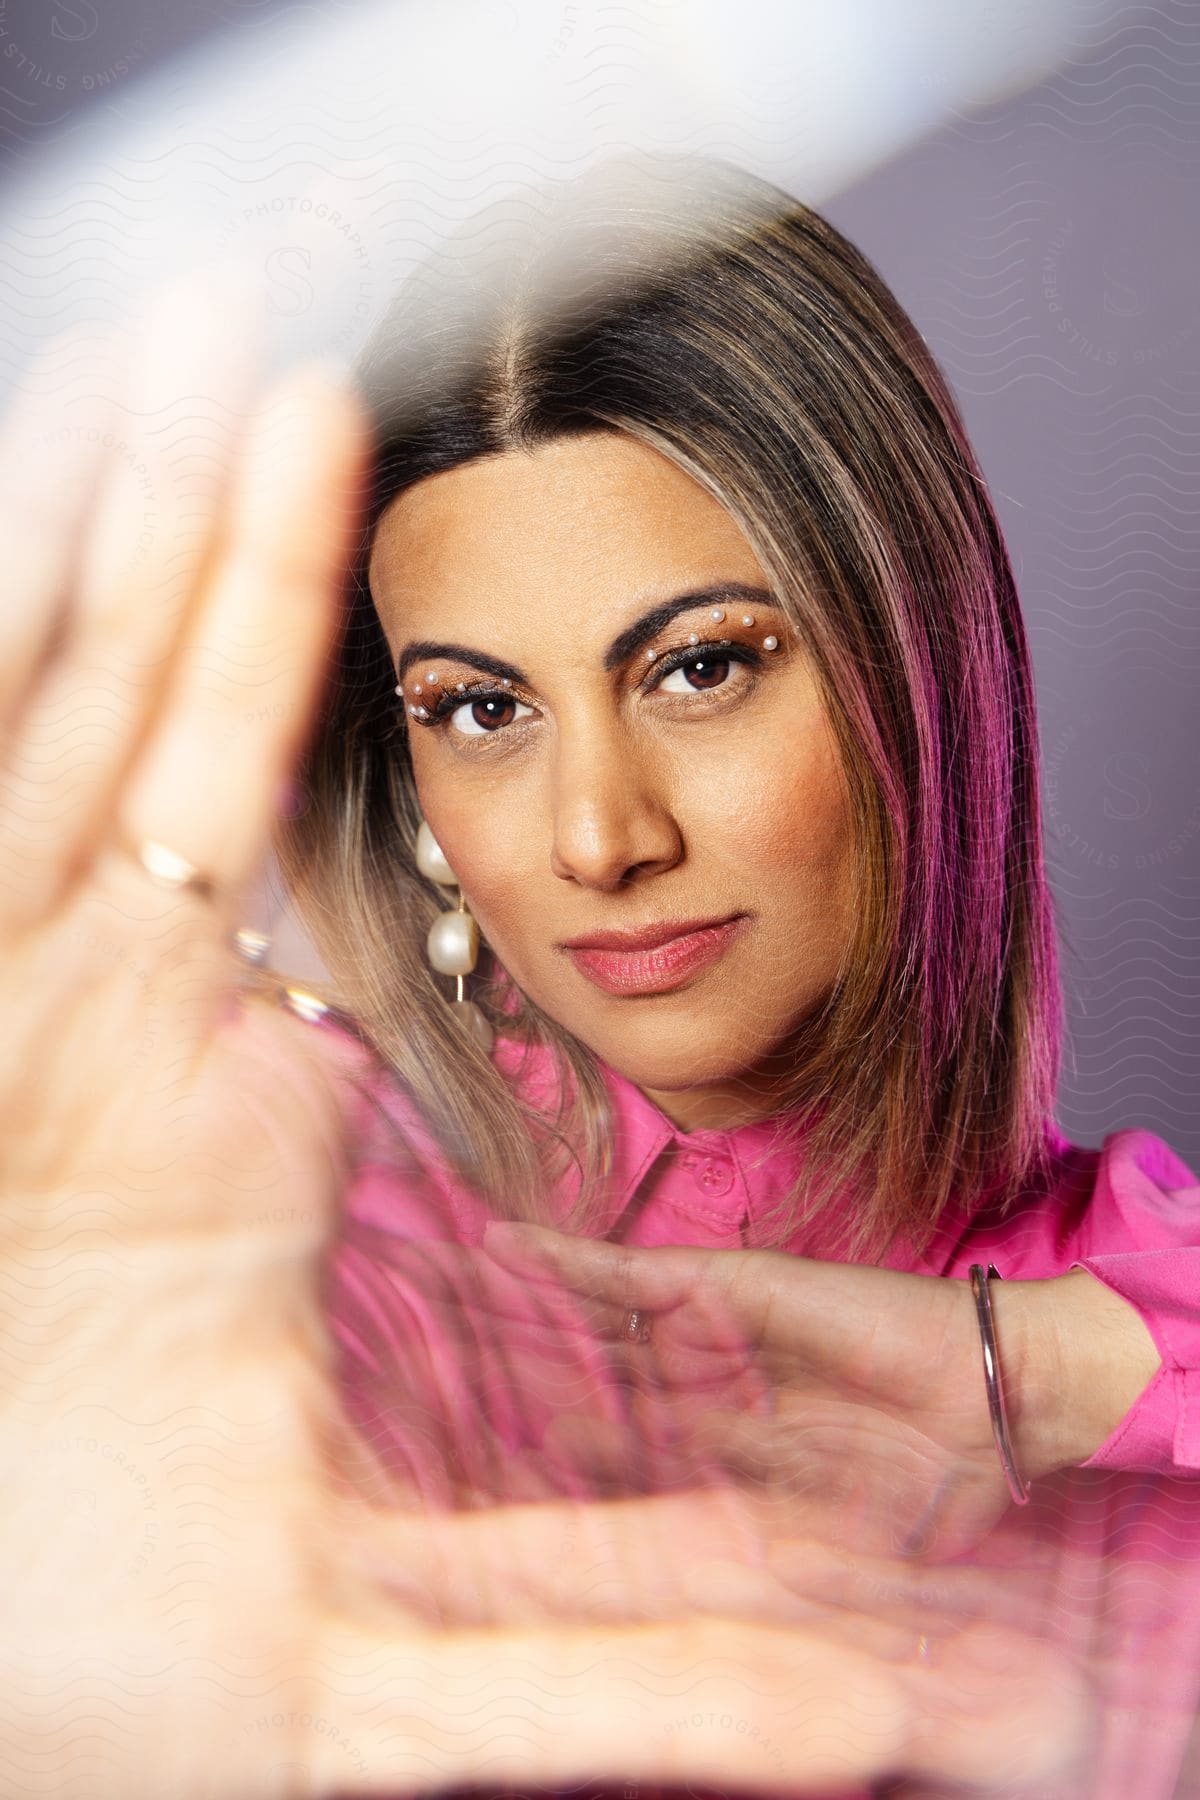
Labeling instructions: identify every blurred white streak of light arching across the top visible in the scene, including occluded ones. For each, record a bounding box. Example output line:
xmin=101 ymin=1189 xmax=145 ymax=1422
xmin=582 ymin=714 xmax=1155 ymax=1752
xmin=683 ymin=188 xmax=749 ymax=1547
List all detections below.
xmin=0 ymin=0 xmax=1114 ymax=385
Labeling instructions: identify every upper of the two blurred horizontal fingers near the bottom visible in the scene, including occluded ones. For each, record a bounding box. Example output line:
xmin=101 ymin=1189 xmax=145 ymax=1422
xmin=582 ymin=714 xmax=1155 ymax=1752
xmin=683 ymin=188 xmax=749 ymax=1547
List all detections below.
xmin=344 ymin=1487 xmax=993 ymax=1654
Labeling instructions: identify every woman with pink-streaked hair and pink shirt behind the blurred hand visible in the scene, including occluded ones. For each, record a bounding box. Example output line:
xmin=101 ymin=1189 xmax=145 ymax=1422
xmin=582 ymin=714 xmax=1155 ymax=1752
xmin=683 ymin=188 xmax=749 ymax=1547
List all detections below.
xmin=262 ymin=151 xmax=1200 ymax=1793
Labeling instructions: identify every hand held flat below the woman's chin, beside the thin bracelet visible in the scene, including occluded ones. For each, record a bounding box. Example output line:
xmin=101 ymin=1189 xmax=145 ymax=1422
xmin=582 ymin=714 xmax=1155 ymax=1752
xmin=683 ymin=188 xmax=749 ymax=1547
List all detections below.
xmin=484 ymin=1224 xmax=1052 ymax=1559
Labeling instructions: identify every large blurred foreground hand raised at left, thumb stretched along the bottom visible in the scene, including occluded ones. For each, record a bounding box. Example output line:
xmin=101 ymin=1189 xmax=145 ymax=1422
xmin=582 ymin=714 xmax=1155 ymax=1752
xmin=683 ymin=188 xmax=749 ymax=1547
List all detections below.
xmin=0 ymin=277 xmax=1085 ymax=1800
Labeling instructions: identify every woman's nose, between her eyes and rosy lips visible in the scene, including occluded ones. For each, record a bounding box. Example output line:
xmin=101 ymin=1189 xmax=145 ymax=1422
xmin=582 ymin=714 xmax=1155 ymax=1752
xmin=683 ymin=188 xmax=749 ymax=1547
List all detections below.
xmin=551 ymin=736 xmax=684 ymax=889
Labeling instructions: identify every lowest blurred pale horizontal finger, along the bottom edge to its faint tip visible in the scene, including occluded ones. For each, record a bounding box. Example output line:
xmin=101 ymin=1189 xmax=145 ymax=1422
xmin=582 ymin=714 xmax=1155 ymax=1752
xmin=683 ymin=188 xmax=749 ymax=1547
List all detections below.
xmin=306 ymin=1618 xmax=1090 ymax=1793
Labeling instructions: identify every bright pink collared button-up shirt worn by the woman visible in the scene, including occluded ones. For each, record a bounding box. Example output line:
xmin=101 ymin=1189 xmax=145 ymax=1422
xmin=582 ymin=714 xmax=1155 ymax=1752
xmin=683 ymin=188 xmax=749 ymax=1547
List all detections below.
xmin=324 ymin=1019 xmax=1200 ymax=1800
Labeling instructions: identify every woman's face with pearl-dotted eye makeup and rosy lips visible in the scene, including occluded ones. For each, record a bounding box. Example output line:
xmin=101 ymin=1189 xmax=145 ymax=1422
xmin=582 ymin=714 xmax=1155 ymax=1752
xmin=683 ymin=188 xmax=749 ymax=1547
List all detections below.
xmin=371 ymin=432 xmax=855 ymax=1129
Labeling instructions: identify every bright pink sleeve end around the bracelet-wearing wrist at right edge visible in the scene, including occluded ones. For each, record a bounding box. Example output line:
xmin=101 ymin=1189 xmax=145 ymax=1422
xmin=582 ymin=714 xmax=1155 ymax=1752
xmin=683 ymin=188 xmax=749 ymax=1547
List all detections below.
xmin=1070 ymin=1130 xmax=1200 ymax=1474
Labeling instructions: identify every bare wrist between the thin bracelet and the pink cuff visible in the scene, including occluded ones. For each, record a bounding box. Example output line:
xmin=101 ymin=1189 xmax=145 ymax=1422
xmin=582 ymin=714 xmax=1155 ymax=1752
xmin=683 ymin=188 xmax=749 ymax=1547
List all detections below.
xmin=990 ymin=1269 xmax=1160 ymax=1481
